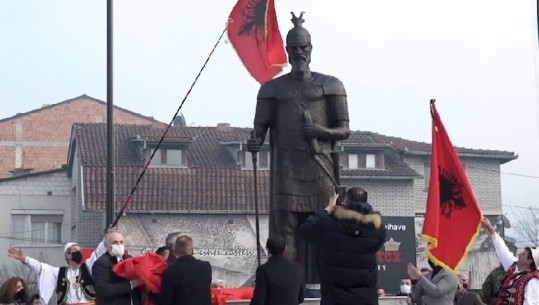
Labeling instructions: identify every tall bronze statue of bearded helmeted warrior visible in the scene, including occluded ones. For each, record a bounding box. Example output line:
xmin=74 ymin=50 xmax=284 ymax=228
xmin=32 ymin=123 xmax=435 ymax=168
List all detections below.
xmin=248 ymin=13 xmax=350 ymax=283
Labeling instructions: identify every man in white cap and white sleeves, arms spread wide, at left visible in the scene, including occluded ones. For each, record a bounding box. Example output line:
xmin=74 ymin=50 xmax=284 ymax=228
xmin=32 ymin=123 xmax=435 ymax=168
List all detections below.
xmin=8 ymin=229 xmax=114 ymax=305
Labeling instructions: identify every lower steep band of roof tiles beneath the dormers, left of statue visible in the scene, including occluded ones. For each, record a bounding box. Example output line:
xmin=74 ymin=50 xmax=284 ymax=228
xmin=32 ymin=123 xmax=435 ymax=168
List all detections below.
xmin=84 ymin=167 xmax=269 ymax=212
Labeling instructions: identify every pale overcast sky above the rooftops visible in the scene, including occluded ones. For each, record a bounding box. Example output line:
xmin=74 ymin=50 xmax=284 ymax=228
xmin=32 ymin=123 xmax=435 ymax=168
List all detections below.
xmin=0 ymin=0 xmax=539 ymax=213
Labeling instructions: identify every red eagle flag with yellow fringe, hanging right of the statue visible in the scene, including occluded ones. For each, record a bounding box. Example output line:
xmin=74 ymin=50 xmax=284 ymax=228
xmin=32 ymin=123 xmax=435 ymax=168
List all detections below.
xmin=423 ymin=100 xmax=483 ymax=271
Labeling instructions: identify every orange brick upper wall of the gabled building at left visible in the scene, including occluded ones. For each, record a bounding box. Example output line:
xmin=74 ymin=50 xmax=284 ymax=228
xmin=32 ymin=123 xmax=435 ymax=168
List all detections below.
xmin=0 ymin=96 xmax=161 ymax=178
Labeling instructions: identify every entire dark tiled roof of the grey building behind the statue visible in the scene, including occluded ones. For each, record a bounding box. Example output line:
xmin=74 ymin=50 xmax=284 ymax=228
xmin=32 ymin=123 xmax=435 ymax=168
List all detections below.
xmin=70 ymin=124 xmax=516 ymax=212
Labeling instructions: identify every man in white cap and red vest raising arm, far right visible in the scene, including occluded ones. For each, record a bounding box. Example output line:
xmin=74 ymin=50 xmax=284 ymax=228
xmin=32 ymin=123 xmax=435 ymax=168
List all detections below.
xmin=482 ymin=217 xmax=539 ymax=305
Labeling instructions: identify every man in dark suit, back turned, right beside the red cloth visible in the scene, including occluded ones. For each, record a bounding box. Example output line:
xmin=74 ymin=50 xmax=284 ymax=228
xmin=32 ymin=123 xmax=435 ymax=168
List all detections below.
xmin=158 ymin=235 xmax=211 ymax=305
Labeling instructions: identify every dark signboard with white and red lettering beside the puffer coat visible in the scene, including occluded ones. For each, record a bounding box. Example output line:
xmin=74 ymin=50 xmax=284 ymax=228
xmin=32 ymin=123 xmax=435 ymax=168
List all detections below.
xmin=376 ymin=216 xmax=416 ymax=294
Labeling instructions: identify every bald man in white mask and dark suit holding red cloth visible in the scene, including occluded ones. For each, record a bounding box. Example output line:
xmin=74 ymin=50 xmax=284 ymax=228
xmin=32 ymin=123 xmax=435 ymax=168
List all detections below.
xmin=92 ymin=232 xmax=142 ymax=305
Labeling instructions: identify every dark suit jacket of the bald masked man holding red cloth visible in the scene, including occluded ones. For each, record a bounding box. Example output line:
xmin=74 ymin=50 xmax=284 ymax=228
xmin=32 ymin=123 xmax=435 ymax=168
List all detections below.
xmin=92 ymin=252 xmax=142 ymax=305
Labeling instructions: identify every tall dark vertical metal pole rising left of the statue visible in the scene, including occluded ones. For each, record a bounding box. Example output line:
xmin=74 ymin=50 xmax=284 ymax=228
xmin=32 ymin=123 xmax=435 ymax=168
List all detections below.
xmin=105 ymin=0 xmax=114 ymax=230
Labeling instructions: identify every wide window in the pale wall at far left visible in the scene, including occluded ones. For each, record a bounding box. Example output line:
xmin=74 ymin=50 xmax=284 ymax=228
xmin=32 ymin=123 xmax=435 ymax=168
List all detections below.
xmin=11 ymin=215 xmax=63 ymax=245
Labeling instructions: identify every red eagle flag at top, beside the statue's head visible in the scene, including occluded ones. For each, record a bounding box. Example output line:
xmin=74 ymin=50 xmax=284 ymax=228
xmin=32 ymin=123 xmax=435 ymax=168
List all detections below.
xmin=228 ymin=0 xmax=287 ymax=84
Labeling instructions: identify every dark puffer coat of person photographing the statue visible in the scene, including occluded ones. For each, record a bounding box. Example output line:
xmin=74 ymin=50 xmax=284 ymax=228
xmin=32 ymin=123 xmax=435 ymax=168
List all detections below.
xmin=300 ymin=206 xmax=386 ymax=305
